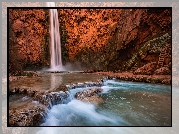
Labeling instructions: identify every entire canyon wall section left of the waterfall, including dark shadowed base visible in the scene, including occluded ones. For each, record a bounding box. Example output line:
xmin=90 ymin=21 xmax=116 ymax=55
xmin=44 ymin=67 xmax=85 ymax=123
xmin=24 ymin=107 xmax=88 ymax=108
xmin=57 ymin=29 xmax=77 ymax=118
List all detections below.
xmin=9 ymin=9 xmax=50 ymax=74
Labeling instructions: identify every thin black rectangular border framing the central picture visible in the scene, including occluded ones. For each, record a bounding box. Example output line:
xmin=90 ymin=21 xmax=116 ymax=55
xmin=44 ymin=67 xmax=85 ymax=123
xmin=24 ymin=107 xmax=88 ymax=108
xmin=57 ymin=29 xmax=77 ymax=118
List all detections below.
xmin=7 ymin=7 xmax=173 ymax=127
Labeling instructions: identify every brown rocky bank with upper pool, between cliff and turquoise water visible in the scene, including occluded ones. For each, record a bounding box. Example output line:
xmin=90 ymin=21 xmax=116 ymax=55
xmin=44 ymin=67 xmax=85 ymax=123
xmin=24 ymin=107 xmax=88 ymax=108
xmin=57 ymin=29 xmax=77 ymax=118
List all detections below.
xmin=9 ymin=71 xmax=171 ymax=126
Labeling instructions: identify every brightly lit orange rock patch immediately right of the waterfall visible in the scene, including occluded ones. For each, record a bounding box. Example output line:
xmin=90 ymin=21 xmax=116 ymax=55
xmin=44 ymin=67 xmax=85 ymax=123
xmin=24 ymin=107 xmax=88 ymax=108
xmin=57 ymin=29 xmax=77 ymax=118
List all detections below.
xmin=59 ymin=9 xmax=121 ymax=61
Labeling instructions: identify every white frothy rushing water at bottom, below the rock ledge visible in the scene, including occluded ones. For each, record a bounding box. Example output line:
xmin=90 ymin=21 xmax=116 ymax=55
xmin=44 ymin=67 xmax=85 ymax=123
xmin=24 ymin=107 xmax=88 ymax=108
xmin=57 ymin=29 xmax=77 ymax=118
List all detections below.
xmin=42 ymin=99 xmax=126 ymax=126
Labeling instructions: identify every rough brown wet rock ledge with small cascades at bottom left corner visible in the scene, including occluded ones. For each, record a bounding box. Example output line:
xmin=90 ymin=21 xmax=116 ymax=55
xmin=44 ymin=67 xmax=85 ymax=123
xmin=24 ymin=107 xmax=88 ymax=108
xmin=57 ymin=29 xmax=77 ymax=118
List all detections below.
xmin=9 ymin=88 xmax=69 ymax=126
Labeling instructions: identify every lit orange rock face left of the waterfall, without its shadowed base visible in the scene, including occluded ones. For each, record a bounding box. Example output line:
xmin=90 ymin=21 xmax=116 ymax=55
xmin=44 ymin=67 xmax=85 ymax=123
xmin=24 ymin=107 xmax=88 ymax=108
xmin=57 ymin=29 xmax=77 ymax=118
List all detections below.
xmin=9 ymin=9 xmax=48 ymax=70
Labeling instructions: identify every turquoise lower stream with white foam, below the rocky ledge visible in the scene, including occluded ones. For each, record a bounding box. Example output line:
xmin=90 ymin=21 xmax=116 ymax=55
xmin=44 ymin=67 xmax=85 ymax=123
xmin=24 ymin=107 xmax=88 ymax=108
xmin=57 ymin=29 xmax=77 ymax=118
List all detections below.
xmin=41 ymin=80 xmax=171 ymax=126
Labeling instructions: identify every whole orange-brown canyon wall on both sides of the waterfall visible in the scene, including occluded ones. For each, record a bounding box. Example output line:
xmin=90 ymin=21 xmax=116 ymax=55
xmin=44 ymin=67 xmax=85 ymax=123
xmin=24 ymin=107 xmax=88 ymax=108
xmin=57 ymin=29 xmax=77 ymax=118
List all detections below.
xmin=9 ymin=8 xmax=171 ymax=74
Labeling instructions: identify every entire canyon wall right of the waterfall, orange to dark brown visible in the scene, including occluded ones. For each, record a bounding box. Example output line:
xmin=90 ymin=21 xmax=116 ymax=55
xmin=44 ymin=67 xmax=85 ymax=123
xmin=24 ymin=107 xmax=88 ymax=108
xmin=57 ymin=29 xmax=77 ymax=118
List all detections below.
xmin=59 ymin=9 xmax=171 ymax=71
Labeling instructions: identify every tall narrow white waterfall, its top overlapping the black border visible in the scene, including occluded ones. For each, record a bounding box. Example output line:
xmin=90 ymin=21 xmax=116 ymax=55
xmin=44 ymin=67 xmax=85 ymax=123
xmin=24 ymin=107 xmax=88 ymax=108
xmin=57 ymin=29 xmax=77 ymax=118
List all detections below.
xmin=47 ymin=2 xmax=62 ymax=71
